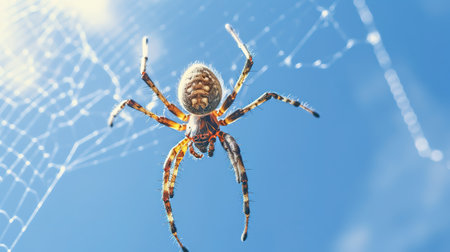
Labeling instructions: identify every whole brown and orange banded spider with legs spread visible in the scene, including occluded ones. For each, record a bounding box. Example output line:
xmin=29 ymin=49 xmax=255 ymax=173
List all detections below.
xmin=108 ymin=24 xmax=319 ymax=252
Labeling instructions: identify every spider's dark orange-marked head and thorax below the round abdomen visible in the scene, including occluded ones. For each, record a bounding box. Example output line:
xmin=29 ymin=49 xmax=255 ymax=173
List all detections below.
xmin=186 ymin=114 xmax=220 ymax=153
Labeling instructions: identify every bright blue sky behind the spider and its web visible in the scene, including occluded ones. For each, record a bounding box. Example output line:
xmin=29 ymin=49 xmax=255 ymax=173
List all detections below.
xmin=0 ymin=0 xmax=450 ymax=251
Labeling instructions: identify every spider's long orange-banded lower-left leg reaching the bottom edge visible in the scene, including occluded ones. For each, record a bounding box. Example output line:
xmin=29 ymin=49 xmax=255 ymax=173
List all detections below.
xmin=162 ymin=138 xmax=190 ymax=252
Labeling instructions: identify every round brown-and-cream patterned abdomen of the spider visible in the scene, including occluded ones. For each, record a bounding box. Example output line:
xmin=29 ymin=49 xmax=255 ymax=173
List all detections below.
xmin=178 ymin=63 xmax=222 ymax=115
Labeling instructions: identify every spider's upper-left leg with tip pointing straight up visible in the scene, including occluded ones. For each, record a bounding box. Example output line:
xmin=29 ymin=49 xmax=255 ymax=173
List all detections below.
xmin=141 ymin=37 xmax=189 ymax=122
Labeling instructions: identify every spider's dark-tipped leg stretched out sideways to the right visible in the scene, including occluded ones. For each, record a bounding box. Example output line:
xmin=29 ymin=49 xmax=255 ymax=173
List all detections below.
xmin=219 ymin=93 xmax=319 ymax=126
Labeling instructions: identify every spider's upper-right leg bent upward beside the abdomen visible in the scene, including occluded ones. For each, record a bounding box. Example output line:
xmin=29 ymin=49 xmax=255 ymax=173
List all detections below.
xmin=217 ymin=24 xmax=253 ymax=116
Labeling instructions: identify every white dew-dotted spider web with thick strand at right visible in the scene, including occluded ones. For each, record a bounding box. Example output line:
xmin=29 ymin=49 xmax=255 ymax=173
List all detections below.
xmin=0 ymin=0 xmax=443 ymax=251
